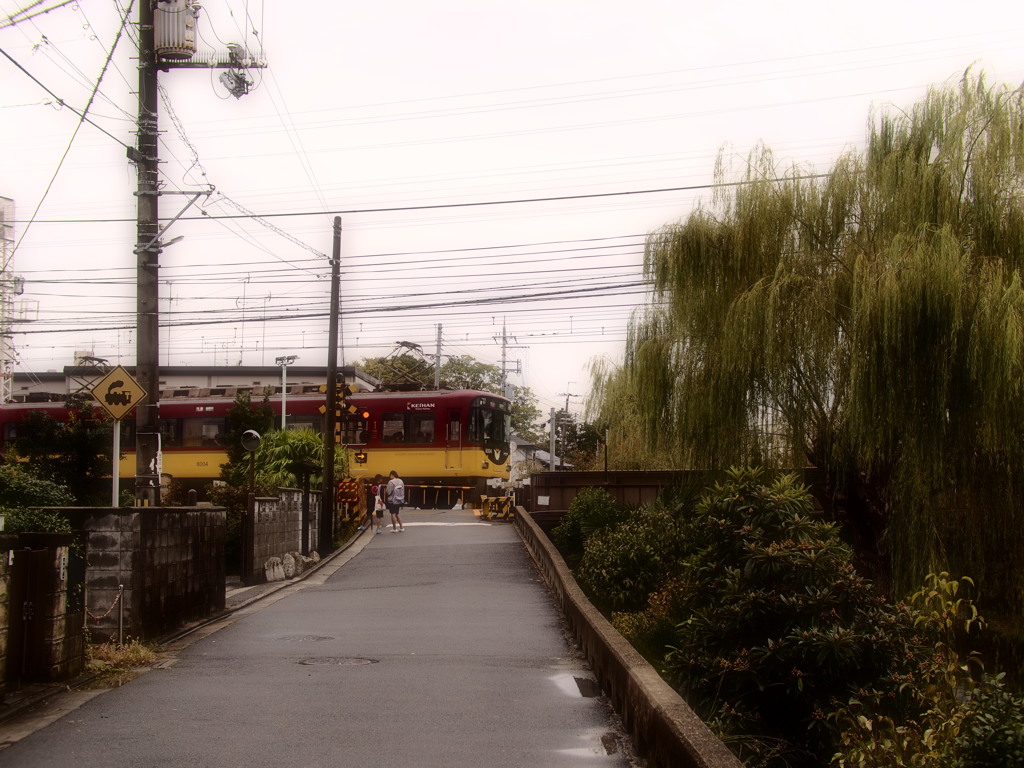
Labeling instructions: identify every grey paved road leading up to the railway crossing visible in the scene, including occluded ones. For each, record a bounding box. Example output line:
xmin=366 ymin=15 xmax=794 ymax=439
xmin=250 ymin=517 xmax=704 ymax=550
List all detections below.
xmin=0 ymin=510 xmax=632 ymax=768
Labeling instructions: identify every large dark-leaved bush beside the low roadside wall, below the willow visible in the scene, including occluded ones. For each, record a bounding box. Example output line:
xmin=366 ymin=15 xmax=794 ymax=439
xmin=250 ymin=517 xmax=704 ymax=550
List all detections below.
xmin=654 ymin=469 xmax=922 ymax=767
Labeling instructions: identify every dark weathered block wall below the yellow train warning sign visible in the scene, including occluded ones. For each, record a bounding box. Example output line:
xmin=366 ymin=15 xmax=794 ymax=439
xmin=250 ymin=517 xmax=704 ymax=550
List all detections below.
xmin=59 ymin=507 xmax=226 ymax=642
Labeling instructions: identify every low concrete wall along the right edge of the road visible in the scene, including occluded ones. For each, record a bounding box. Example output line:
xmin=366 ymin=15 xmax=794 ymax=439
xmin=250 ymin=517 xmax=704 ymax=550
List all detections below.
xmin=514 ymin=507 xmax=742 ymax=768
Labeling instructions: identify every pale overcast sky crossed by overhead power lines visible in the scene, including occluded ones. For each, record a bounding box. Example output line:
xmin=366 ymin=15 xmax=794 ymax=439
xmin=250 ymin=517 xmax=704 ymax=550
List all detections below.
xmin=0 ymin=0 xmax=1024 ymax=421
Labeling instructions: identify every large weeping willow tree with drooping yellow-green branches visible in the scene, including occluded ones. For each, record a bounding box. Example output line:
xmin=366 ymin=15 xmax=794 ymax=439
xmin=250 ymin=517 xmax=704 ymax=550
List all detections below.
xmin=602 ymin=72 xmax=1024 ymax=615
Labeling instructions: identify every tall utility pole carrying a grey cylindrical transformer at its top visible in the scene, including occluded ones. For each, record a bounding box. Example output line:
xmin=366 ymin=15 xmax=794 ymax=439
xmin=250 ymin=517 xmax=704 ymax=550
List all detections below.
xmin=132 ymin=0 xmax=266 ymax=507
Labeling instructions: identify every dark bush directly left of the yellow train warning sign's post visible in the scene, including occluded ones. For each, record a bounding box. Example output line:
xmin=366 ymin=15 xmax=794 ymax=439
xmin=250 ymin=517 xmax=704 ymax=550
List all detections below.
xmin=11 ymin=394 xmax=115 ymax=506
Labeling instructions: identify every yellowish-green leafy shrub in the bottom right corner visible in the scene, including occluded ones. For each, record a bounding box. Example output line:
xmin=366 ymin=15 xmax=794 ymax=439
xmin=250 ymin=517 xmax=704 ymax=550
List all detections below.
xmin=831 ymin=573 xmax=1024 ymax=768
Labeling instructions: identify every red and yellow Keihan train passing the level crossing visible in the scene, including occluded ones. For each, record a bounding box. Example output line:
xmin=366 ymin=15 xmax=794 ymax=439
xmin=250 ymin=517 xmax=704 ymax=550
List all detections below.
xmin=0 ymin=384 xmax=512 ymax=508
